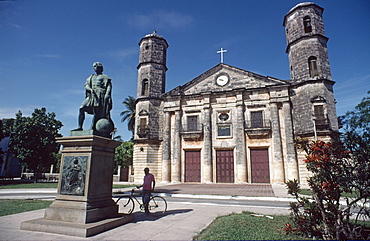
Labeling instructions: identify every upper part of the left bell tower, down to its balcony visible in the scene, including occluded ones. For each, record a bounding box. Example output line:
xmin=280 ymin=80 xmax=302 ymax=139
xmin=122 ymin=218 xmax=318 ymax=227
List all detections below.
xmin=134 ymin=31 xmax=168 ymax=140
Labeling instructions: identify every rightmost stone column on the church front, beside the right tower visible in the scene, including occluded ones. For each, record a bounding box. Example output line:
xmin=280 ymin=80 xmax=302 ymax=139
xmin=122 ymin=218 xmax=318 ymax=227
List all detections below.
xmin=283 ymin=102 xmax=299 ymax=180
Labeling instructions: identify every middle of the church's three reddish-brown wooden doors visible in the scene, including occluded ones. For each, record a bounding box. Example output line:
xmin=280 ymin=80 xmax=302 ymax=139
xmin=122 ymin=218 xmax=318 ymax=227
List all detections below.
xmin=216 ymin=150 xmax=234 ymax=183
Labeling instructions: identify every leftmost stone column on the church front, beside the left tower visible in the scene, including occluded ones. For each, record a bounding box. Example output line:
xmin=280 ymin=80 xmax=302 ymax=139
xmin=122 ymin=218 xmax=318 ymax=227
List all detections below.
xmin=162 ymin=111 xmax=171 ymax=182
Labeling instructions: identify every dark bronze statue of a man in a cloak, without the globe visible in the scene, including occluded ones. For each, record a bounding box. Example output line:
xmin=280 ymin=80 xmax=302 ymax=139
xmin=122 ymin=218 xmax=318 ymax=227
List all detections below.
xmin=74 ymin=62 xmax=112 ymax=131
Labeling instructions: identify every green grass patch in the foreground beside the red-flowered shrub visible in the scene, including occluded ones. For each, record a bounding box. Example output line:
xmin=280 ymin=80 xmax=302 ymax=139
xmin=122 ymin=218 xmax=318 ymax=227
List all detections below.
xmin=194 ymin=212 xmax=312 ymax=240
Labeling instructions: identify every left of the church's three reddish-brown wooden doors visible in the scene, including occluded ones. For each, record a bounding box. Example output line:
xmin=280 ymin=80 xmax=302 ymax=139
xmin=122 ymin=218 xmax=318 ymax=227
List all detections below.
xmin=185 ymin=151 xmax=200 ymax=182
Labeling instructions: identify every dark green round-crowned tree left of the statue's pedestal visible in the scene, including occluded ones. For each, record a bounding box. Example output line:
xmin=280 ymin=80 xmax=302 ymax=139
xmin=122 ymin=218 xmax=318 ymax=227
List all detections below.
xmin=8 ymin=108 xmax=63 ymax=180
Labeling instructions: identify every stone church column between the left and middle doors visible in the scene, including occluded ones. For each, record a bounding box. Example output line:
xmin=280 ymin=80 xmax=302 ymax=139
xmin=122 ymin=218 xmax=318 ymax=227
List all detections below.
xmin=202 ymin=96 xmax=213 ymax=183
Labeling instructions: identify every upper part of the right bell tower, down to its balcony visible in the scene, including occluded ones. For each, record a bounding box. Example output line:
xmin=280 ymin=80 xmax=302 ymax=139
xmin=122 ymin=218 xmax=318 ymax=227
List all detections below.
xmin=283 ymin=2 xmax=338 ymax=140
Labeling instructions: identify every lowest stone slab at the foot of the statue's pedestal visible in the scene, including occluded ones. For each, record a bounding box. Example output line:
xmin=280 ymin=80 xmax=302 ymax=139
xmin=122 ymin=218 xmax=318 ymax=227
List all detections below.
xmin=21 ymin=214 xmax=135 ymax=238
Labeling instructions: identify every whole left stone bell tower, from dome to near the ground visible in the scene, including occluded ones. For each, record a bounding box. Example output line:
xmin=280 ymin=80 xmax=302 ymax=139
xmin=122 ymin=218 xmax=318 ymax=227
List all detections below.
xmin=134 ymin=31 xmax=168 ymax=180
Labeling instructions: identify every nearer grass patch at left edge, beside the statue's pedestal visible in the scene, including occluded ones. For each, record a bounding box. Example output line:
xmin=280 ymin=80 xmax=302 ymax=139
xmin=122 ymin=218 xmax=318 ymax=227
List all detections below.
xmin=0 ymin=199 xmax=53 ymax=216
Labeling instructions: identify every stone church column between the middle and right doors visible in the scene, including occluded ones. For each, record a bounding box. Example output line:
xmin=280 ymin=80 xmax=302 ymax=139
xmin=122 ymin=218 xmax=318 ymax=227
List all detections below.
xmin=234 ymin=93 xmax=247 ymax=182
